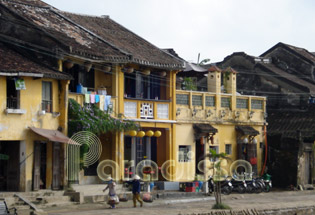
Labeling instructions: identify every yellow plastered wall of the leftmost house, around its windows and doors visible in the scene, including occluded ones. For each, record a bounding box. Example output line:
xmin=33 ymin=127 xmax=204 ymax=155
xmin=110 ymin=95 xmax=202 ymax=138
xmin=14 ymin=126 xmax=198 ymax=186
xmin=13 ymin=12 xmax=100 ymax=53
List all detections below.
xmin=0 ymin=76 xmax=67 ymax=191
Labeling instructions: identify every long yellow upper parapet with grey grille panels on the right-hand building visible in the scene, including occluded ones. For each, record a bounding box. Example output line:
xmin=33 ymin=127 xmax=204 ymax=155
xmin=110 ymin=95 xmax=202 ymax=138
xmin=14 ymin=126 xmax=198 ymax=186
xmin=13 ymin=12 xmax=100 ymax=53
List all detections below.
xmin=176 ymin=90 xmax=266 ymax=123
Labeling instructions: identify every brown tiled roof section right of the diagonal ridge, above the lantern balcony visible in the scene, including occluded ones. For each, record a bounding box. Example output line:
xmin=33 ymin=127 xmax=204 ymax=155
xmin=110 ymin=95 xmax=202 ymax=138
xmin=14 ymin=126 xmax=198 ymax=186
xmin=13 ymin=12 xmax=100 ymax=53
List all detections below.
xmin=62 ymin=12 xmax=183 ymax=68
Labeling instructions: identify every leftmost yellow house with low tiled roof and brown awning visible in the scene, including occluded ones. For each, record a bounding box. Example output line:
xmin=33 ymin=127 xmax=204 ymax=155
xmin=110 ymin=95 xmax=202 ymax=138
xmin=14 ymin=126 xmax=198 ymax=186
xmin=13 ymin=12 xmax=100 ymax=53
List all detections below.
xmin=0 ymin=42 xmax=71 ymax=191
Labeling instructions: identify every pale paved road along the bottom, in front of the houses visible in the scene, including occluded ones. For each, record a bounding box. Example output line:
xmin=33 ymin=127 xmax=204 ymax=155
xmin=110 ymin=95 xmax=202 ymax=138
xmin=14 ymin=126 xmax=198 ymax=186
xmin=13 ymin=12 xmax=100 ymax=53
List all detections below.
xmin=45 ymin=191 xmax=315 ymax=215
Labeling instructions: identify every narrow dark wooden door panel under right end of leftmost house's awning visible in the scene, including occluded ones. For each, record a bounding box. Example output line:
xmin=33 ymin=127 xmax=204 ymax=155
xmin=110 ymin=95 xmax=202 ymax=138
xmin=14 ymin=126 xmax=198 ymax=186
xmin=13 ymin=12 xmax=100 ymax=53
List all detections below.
xmin=52 ymin=143 xmax=61 ymax=190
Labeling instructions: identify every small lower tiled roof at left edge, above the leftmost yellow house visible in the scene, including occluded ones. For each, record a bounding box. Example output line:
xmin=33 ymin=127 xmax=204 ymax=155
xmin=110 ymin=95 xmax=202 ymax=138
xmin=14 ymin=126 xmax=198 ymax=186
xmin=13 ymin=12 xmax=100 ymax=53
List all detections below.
xmin=0 ymin=43 xmax=72 ymax=80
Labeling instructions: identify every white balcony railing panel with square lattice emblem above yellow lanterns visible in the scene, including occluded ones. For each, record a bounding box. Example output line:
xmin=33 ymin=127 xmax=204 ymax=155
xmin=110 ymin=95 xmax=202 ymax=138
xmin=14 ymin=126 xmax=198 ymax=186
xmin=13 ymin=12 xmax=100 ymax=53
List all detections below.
xmin=124 ymin=99 xmax=170 ymax=120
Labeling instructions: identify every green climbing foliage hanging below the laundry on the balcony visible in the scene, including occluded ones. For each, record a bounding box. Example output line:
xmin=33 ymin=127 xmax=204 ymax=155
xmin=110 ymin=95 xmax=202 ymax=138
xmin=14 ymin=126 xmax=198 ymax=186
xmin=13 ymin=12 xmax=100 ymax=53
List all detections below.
xmin=68 ymin=99 xmax=138 ymax=136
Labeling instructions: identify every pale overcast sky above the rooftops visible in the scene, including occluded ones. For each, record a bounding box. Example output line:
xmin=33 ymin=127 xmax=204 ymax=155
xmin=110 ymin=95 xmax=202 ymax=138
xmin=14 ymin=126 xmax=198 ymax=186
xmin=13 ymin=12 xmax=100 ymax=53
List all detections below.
xmin=44 ymin=0 xmax=315 ymax=62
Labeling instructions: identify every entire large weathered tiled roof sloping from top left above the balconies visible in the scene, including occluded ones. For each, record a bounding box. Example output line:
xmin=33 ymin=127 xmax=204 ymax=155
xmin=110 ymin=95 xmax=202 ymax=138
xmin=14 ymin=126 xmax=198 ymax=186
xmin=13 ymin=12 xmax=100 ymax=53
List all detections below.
xmin=0 ymin=0 xmax=184 ymax=69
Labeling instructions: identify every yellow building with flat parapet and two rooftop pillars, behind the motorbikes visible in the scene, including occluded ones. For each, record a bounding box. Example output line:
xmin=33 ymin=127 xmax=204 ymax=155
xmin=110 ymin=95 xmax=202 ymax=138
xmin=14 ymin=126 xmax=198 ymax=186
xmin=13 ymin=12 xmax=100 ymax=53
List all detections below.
xmin=174 ymin=66 xmax=266 ymax=181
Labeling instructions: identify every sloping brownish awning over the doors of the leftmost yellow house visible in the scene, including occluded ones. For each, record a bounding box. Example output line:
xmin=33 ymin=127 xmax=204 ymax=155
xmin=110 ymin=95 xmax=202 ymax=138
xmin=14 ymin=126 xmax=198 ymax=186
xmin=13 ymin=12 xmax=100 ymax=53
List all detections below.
xmin=29 ymin=127 xmax=77 ymax=145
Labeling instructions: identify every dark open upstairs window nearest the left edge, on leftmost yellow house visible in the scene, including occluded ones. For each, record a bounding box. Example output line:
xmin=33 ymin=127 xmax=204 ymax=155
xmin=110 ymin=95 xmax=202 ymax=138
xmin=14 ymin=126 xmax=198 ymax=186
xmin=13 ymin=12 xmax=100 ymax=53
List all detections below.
xmin=7 ymin=77 xmax=20 ymax=109
